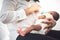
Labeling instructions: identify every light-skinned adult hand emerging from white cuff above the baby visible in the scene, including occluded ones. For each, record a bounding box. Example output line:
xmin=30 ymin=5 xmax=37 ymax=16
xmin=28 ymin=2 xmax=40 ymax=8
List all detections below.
xmin=25 ymin=3 xmax=40 ymax=15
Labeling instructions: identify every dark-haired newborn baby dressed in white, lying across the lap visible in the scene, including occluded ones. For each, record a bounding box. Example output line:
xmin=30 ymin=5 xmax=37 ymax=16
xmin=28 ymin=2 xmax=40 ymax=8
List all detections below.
xmin=35 ymin=11 xmax=59 ymax=35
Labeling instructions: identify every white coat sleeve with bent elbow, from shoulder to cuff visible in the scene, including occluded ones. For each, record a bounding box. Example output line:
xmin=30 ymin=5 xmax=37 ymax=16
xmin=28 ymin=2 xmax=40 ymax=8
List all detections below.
xmin=0 ymin=0 xmax=26 ymax=23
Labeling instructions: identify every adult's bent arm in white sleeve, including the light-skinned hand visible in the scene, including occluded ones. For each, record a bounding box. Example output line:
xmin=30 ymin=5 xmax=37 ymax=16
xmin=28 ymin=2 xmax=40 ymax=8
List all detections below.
xmin=0 ymin=0 xmax=40 ymax=23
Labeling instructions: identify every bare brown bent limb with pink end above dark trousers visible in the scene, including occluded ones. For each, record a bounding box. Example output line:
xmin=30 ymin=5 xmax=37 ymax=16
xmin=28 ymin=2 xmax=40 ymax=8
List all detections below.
xmin=18 ymin=25 xmax=41 ymax=36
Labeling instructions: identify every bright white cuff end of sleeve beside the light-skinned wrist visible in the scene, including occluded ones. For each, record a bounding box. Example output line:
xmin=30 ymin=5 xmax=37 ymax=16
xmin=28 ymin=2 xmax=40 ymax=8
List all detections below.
xmin=11 ymin=9 xmax=27 ymax=21
